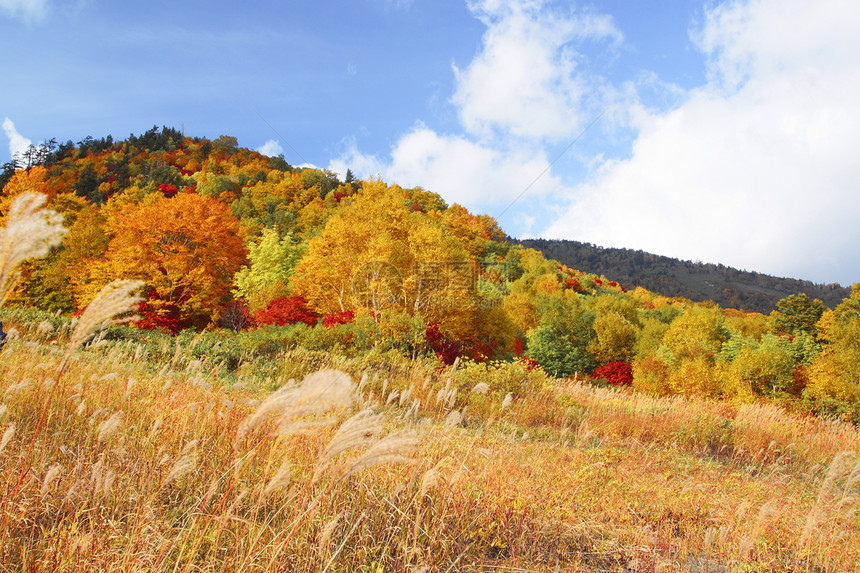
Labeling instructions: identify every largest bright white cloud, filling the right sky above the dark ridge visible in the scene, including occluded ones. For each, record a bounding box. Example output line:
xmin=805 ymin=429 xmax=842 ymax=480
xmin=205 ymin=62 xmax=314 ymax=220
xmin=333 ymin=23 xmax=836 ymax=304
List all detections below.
xmin=544 ymin=0 xmax=860 ymax=284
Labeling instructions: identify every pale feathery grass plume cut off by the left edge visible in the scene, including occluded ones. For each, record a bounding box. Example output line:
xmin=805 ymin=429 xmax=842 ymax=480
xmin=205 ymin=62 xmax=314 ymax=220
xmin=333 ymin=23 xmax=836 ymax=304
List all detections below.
xmin=0 ymin=192 xmax=68 ymax=306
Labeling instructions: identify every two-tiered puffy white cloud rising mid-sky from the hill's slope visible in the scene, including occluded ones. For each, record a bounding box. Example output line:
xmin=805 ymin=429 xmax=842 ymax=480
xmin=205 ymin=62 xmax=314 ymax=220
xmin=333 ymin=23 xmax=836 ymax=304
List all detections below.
xmin=329 ymin=0 xmax=622 ymax=225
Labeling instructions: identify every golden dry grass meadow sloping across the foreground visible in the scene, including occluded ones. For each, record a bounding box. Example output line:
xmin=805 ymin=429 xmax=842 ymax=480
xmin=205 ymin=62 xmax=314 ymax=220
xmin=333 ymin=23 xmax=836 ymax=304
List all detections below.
xmin=0 ymin=309 xmax=860 ymax=572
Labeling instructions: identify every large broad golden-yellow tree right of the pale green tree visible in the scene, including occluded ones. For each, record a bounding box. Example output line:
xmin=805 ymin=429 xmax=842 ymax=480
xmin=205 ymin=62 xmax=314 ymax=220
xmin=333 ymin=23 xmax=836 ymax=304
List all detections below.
xmin=291 ymin=181 xmax=508 ymax=349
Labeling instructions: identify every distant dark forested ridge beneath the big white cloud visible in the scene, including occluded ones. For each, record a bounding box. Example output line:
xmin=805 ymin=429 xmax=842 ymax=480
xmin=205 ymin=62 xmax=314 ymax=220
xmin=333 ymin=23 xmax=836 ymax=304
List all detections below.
xmin=519 ymin=239 xmax=850 ymax=313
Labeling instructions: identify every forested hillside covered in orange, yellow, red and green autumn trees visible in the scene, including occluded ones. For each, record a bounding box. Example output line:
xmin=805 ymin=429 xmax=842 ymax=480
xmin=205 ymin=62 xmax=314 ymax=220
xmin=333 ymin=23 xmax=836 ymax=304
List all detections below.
xmin=0 ymin=128 xmax=860 ymax=421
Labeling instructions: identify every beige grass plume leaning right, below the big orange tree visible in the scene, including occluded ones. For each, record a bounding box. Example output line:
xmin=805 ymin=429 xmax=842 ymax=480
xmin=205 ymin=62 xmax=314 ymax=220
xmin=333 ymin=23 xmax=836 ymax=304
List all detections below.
xmin=57 ymin=279 xmax=143 ymax=378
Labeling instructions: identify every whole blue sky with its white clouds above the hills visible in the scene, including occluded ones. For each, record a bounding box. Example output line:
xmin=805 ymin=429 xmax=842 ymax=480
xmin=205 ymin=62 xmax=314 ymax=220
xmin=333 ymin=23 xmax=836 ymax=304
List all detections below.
xmin=0 ymin=0 xmax=860 ymax=284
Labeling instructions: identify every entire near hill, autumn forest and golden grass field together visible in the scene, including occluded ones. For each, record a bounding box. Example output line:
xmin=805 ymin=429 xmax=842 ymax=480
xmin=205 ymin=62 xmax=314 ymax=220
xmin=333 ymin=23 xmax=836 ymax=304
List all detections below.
xmin=0 ymin=128 xmax=860 ymax=572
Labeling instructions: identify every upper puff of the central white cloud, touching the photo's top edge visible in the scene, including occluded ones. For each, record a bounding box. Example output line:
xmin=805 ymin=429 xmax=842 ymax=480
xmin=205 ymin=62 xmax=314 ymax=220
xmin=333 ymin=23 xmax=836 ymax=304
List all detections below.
xmin=452 ymin=0 xmax=622 ymax=139
